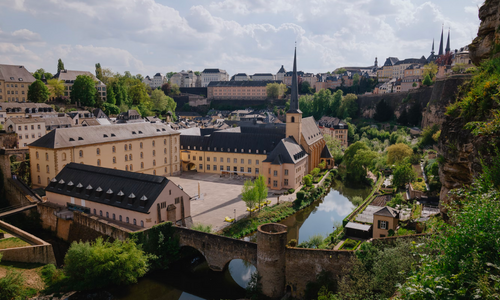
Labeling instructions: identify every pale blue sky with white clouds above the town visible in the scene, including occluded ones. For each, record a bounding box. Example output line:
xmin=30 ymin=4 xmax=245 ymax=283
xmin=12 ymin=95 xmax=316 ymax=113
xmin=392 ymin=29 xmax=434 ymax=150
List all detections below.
xmin=0 ymin=0 xmax=483 ymax=76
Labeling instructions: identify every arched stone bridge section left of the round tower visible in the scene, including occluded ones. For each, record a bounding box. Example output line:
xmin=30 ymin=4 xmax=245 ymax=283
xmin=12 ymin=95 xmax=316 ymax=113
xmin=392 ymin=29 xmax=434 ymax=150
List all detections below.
xmin=174 ymin=227 xmax=257 ymax=271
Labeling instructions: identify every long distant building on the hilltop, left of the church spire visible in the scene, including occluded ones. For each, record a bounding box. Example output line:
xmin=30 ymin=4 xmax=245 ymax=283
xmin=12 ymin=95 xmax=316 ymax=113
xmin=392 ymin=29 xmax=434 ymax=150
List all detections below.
xmin=207 ymin=80 xmax=280 ymax=100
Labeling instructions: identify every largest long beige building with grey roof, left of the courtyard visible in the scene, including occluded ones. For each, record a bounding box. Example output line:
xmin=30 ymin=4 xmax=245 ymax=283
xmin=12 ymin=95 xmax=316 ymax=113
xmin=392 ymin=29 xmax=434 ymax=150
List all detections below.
xmin=28 ymin=123 xmax=181 ymax=188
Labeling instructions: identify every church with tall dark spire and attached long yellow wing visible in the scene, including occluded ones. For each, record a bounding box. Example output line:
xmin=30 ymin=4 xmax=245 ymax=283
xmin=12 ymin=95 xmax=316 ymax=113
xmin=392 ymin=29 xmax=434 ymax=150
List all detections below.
xmin=179 ymin=50 xmax=334 ymax=190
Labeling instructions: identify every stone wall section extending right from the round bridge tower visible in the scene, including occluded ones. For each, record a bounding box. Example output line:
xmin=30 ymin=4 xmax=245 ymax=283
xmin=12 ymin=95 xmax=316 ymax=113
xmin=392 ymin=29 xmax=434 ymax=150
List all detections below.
xmin=286 ymin=248 xmax=354 ymax=298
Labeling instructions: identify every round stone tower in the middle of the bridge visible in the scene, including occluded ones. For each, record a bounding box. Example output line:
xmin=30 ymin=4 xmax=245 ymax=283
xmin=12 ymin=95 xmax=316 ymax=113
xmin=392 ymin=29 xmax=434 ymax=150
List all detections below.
xmin=257 ymin=223 xmax=287 ymax=298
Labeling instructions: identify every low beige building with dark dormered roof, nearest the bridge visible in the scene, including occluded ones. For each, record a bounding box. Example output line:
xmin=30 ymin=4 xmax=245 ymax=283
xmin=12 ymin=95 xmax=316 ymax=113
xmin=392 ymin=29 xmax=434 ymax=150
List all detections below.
xmin=45 ymin=163 xmax=192 ymax=229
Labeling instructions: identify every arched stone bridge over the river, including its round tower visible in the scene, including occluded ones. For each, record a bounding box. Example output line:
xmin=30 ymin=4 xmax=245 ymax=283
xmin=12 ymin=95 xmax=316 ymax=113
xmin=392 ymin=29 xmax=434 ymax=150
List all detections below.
xmin=175 ymin=223 xmax=353 ymax=298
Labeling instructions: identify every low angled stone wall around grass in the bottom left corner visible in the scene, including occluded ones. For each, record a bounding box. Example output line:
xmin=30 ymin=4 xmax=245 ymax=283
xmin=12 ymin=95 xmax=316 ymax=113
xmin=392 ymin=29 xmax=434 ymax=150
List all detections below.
xmin=0 ymin=221 xmax=56 ymax=264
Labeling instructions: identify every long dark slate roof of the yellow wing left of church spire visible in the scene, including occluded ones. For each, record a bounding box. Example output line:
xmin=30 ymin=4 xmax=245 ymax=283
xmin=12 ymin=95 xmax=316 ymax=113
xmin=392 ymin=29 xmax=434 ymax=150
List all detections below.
xmin=180 ymin=131 xmax=283 ymax=154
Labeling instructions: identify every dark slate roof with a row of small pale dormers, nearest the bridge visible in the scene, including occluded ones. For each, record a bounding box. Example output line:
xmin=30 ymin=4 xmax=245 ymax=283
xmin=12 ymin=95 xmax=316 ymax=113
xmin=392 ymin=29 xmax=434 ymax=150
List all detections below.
xmin=45 ymin=163 xmax=174 ymax=213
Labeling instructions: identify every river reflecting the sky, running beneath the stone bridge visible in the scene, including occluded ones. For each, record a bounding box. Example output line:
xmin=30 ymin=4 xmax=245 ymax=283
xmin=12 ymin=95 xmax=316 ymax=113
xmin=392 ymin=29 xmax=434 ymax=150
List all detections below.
xmin=110 ymin=181 xmax=371 ymax=300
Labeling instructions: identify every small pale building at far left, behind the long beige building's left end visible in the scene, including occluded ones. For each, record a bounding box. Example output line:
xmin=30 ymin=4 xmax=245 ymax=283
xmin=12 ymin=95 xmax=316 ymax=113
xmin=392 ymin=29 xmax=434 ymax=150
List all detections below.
xmin=5 ymin=118 xmax=45 ymax=149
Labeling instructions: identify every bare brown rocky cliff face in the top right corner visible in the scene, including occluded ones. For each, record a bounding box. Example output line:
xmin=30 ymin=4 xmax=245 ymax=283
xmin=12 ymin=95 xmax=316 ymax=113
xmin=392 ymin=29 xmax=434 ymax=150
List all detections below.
xmin=469 ymin=0 xmax=500 ymax=65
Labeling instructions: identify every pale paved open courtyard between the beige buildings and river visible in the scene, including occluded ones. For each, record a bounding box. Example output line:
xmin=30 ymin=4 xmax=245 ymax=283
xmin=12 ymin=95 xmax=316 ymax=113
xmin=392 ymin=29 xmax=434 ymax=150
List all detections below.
xmin=169 ymin=172 xmax=295 ymax=231
